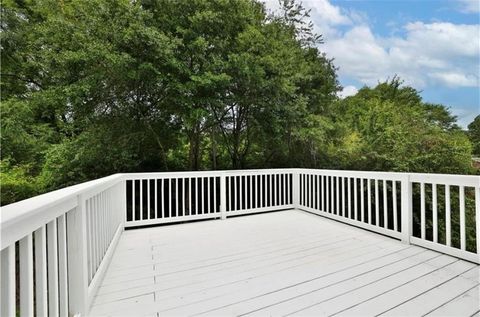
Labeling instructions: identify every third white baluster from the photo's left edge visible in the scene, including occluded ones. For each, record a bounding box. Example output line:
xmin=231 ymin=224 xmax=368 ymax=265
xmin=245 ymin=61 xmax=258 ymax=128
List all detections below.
xmin=35 ymin=226 xmax=48 ymax=316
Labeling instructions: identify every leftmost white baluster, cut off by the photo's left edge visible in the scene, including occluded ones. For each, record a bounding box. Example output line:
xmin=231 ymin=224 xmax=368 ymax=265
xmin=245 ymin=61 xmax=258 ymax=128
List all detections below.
xmin=0 ymin=244 xmax=15 ymax=316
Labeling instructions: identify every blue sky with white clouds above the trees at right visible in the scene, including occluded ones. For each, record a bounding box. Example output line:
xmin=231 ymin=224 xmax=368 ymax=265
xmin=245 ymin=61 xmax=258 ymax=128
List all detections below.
xmin=266 ymin=0 xmax=480 ymax=127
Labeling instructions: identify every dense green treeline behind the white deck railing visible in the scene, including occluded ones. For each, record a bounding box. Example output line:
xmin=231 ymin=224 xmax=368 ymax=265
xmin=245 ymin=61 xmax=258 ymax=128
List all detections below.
xmin=0 ymin=0 xmax=480 ymax=204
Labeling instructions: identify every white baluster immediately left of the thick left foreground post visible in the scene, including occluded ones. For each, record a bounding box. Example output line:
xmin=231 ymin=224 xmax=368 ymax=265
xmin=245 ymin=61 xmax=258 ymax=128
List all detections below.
xmin=58 ymin=214 xmax=68 ymax=316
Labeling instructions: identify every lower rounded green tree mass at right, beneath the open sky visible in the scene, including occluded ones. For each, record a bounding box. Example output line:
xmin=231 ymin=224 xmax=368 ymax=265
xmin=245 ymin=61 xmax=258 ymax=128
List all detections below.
xmin=335 ymin=78 xmax=472 ymax=174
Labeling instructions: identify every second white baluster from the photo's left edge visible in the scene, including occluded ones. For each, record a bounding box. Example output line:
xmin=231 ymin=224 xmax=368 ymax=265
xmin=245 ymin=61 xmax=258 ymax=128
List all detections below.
xmin=19 ymin=234 xmax=33 ymax=317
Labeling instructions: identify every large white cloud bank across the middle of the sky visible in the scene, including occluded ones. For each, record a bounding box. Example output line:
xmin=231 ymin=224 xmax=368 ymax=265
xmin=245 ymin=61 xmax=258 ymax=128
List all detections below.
xmin=267 ymin=0 xmax=480 ymax=89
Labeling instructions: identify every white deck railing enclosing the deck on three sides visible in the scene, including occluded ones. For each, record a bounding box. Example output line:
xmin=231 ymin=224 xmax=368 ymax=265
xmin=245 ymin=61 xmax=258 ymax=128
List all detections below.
xmin=0 ymin=169 xmax=480 ymax=316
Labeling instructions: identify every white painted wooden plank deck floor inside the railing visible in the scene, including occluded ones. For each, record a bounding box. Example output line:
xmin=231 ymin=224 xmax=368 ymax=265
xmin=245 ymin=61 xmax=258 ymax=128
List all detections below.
xmin=90 ymin=210 xmax=480 ymax=316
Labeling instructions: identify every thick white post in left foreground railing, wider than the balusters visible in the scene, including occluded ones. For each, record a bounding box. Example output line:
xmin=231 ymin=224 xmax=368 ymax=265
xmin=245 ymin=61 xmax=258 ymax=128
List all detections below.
xmin=67 ymin=195 xmax=88 ymax=316
